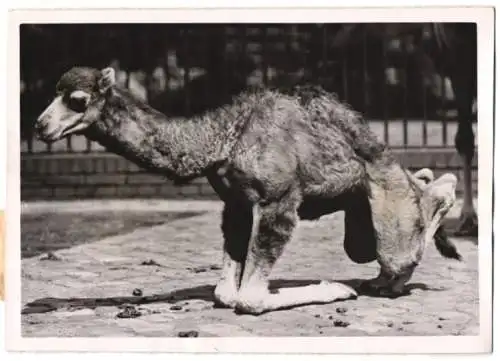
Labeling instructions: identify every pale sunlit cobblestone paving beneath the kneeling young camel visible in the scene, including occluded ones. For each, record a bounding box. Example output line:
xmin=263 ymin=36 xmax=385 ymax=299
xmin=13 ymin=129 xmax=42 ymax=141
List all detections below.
xmin=22 ymin=198 xmax=479 ymax=337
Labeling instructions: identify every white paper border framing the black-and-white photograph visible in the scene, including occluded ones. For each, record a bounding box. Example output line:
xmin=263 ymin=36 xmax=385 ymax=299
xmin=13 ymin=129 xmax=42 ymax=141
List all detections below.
xmin=5 ymin=7 xmax=494 ymax=354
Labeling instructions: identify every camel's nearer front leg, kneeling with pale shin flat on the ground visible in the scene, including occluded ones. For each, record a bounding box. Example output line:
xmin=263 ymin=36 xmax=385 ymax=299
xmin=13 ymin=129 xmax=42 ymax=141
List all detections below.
xmin=236 ymin=193 xmax=357 ymax=315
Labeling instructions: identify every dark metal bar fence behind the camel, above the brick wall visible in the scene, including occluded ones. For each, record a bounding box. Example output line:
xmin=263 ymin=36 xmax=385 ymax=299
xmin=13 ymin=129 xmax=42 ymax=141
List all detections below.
xmin=21 ymin=24 xmax=472 ymax=154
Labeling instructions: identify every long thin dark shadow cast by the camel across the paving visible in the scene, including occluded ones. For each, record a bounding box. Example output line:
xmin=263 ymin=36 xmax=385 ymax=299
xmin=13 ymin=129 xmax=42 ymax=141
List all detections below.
xmin=21 ymin=279 xmax=444 ymax=315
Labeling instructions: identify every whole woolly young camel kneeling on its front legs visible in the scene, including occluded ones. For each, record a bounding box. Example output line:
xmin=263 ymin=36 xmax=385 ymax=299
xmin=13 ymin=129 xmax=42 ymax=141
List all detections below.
xmin=36 ymin=67 xmax=460 ymax=314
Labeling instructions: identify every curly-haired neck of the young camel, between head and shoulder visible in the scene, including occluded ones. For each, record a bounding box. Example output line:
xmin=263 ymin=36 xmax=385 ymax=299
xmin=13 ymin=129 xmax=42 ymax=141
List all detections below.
xmin=89 ymin=89 xmax=249 ymax=180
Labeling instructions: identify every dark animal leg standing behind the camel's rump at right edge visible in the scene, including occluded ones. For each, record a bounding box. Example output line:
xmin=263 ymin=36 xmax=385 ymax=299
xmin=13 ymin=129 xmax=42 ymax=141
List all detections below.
xmin=452 ymin=74 xmax=478 ymax=237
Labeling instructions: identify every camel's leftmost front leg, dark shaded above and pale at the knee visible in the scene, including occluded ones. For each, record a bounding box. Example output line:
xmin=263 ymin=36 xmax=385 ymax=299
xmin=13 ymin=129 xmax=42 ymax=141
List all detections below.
xmin=214 ymin=203 xmax=252 ymax=308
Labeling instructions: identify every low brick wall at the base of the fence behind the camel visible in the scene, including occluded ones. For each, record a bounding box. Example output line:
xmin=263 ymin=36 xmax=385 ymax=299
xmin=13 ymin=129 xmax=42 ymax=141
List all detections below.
xmin=21 ymin=149 xmax=477 ymax=200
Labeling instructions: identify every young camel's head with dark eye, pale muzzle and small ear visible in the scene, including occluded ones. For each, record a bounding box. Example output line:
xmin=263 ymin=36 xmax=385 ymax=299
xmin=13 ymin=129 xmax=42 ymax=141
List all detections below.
xmin=35 ymin=67 xmax=116 ymax=142
